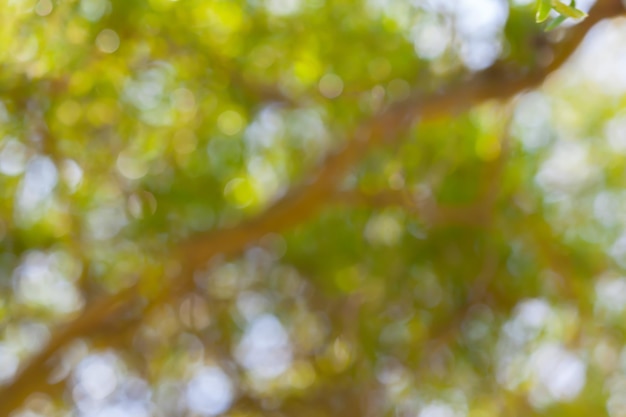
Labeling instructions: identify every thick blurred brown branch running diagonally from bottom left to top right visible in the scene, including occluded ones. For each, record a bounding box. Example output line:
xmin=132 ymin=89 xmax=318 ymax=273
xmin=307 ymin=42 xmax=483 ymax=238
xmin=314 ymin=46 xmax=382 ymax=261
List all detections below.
xmin=0 ymin=0 xmax=624 ymax=416
